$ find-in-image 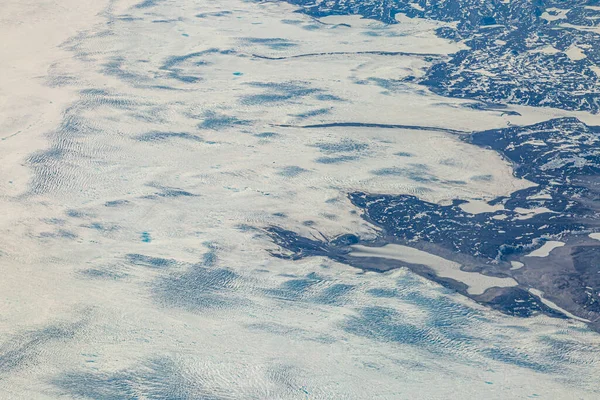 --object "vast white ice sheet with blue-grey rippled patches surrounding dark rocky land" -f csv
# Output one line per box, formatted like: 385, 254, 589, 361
0, 0, 600, 400
